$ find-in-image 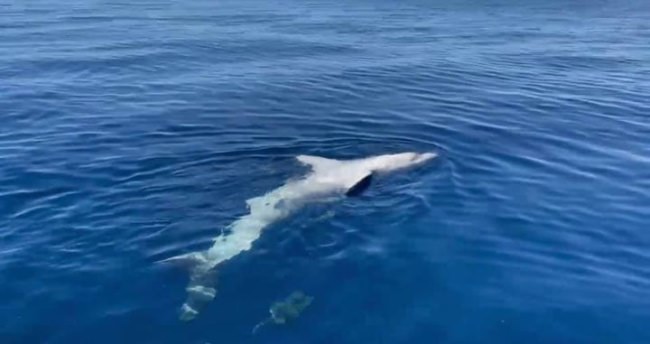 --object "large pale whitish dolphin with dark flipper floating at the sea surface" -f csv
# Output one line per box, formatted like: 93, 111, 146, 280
162, 152, 436, 321
